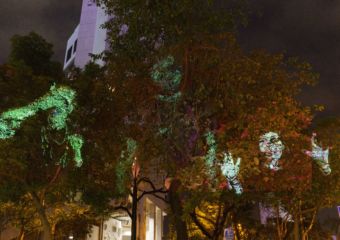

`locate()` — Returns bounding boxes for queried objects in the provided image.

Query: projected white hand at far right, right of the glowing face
[305,133,332,175]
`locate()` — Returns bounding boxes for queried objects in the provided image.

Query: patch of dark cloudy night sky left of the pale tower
[0,0,82,63]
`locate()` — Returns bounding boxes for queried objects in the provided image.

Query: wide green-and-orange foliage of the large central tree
[49,0,337,238]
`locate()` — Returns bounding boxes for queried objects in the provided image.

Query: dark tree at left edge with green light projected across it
[0,33,89,240]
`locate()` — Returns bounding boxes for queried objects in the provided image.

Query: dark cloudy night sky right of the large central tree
[239,0,340,114]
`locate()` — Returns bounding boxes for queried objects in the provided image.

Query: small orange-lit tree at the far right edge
[288,117,340,239]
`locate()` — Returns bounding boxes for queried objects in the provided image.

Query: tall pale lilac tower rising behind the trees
[64,0,109,71]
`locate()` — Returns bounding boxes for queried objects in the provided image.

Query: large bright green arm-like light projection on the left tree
[0,85,84,167]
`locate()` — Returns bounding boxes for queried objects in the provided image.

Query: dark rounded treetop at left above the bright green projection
[0,33,64,111]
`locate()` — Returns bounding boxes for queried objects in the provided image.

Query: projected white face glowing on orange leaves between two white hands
[259,132,285,171]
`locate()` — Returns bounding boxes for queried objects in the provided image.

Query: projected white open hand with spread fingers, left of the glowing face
[221,153,243,195]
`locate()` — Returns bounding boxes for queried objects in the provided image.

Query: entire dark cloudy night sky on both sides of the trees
[0,0,340,115]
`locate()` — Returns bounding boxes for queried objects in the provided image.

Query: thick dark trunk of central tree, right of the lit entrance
[169,179,188,240]
